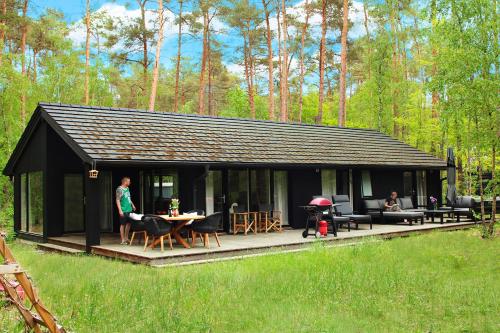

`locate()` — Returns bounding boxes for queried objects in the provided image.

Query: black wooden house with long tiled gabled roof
[3,103,446,246]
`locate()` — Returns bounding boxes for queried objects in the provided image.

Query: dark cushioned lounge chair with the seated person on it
[363,199,424,225]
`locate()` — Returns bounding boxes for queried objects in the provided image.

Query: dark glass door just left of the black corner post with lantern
[64,173,85,233]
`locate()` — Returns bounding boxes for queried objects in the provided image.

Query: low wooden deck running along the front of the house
[49,221,474,266]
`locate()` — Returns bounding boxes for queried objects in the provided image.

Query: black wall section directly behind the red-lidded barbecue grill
[288,170,321,228]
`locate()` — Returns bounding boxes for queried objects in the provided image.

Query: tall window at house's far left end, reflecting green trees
[20,171,43,234]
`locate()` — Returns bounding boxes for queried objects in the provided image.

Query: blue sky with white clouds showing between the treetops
[30,0,372,74]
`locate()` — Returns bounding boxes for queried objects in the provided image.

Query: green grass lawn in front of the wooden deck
[0,230,500,332]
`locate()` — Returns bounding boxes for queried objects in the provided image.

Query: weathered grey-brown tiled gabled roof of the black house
[2,103,446,174]
